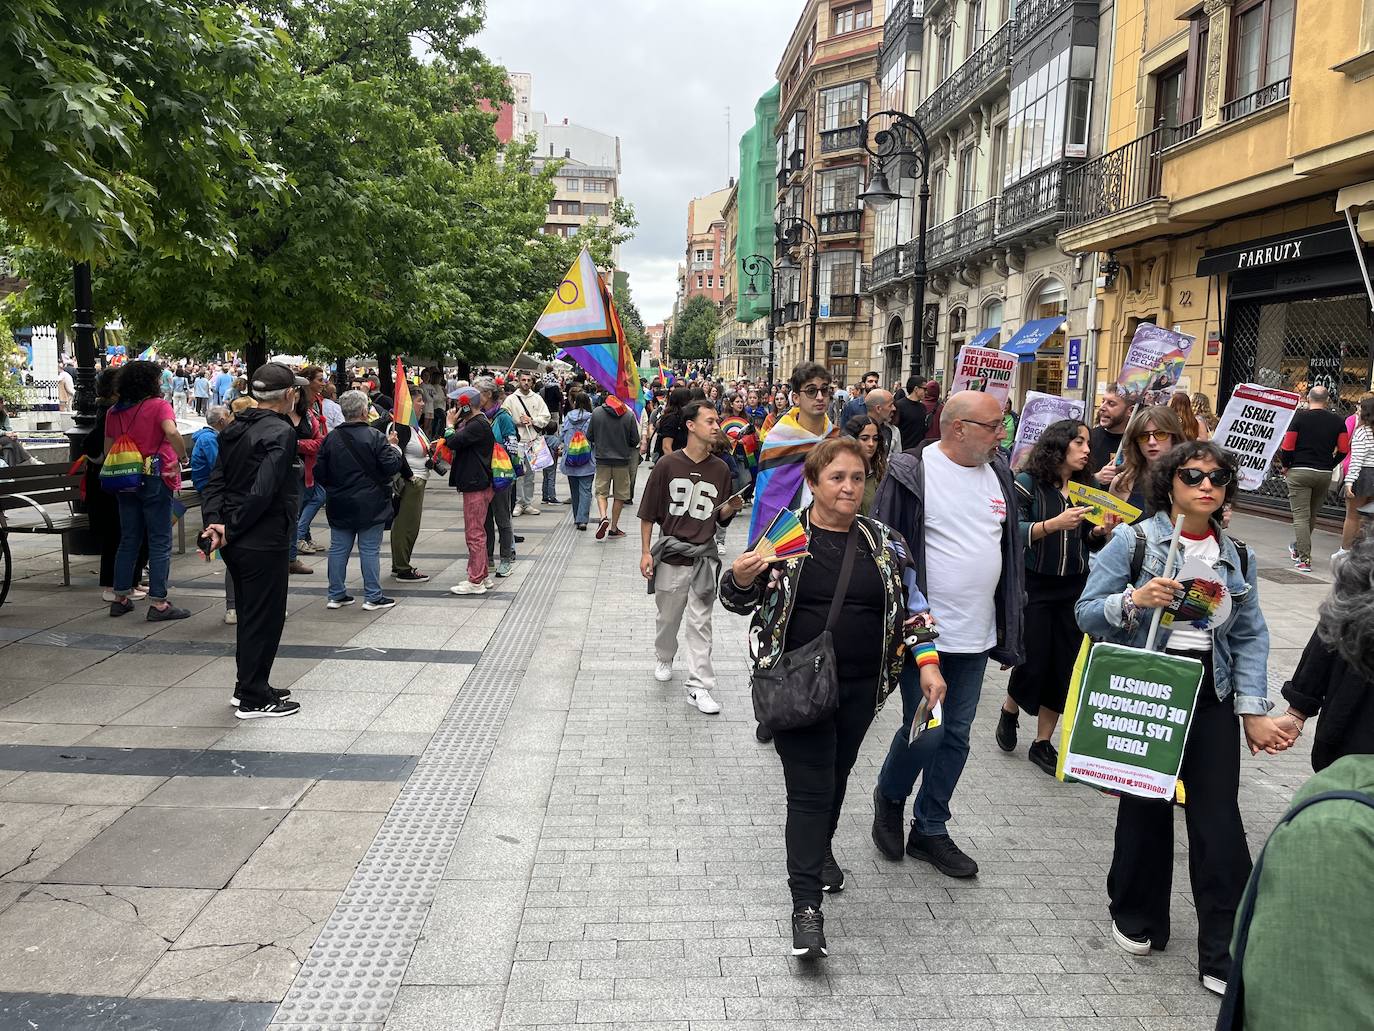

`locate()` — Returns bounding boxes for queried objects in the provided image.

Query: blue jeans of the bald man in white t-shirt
[878,652,988,834]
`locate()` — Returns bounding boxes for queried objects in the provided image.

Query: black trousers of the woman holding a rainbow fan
[774,678,878,910]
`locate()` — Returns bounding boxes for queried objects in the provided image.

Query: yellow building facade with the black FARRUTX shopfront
[1059,0,1374,514]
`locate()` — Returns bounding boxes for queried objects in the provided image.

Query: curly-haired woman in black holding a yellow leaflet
[996,419,1114,777]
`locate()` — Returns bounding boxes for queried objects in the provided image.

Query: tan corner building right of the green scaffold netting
[771,0,883,385]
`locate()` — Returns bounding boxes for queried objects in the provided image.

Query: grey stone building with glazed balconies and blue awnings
[866,0,1099,404]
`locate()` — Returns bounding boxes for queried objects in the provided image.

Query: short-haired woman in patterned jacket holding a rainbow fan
[720,437,944,960]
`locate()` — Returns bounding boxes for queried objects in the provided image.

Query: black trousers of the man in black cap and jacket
[220,547,290,707]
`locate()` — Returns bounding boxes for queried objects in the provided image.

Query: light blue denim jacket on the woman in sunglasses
[1074,513,1274,715]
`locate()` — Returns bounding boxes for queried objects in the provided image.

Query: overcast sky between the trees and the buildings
[477,0,802,323]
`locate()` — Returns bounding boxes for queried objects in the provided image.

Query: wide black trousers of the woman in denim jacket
[1107,656,1250,980]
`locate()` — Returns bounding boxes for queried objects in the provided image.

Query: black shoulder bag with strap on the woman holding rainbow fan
[750,526,859,730]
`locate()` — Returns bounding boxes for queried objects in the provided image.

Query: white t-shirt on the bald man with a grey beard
[922,444,1007,653]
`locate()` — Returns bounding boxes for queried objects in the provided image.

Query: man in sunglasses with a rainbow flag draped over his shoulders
[749,362,840,558]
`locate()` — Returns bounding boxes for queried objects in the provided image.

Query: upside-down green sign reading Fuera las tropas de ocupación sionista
[1061,643,1202,799]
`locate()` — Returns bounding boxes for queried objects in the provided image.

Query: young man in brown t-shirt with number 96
[639,401,745,713]
